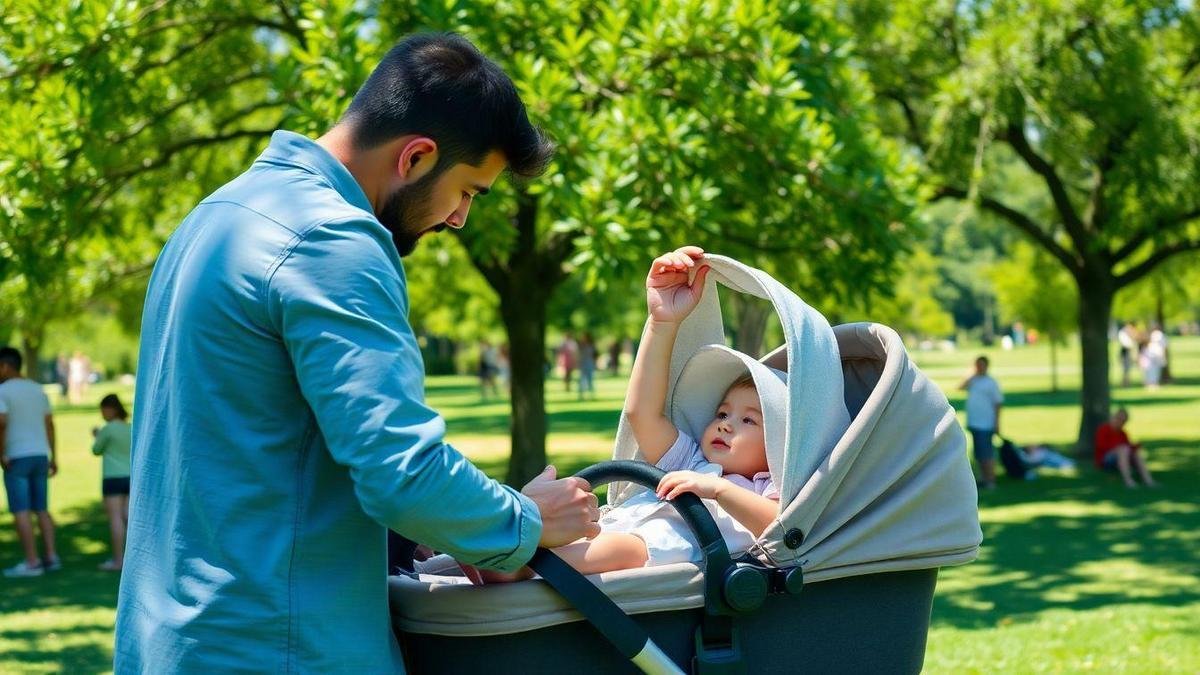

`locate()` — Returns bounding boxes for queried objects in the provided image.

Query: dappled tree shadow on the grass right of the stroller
[934,440,1200,628]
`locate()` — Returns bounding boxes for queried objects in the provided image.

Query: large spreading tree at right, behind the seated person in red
[838,0,1200,447]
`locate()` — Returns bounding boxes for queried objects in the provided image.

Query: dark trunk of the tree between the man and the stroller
[500,276,550,486]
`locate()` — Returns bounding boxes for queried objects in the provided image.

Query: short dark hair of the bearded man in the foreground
[342,32,554,177]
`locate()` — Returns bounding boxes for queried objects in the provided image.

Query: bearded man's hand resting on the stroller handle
[521,466,600,549]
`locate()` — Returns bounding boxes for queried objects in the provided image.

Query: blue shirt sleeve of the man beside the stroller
[264,222,541,571]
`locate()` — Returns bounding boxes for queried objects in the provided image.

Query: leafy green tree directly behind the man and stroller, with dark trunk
[421,1,906,483]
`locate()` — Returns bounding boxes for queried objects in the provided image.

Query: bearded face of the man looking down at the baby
[377,151,505,256]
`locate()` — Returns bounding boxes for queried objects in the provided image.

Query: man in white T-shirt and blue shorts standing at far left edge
[0,347,62,577]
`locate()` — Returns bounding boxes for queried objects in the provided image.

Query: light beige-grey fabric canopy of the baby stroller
[610,255,982,581]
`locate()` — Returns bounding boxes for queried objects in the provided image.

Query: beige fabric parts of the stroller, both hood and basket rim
[390,256,982,635]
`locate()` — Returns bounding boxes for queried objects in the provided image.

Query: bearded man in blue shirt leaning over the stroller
[115,35,599,674]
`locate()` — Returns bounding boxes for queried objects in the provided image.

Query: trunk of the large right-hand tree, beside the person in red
[1076,275,1114,454]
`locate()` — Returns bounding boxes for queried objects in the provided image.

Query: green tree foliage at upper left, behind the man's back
[0,0,287,362]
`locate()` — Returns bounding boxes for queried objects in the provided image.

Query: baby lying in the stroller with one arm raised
[477,246,782,583]
